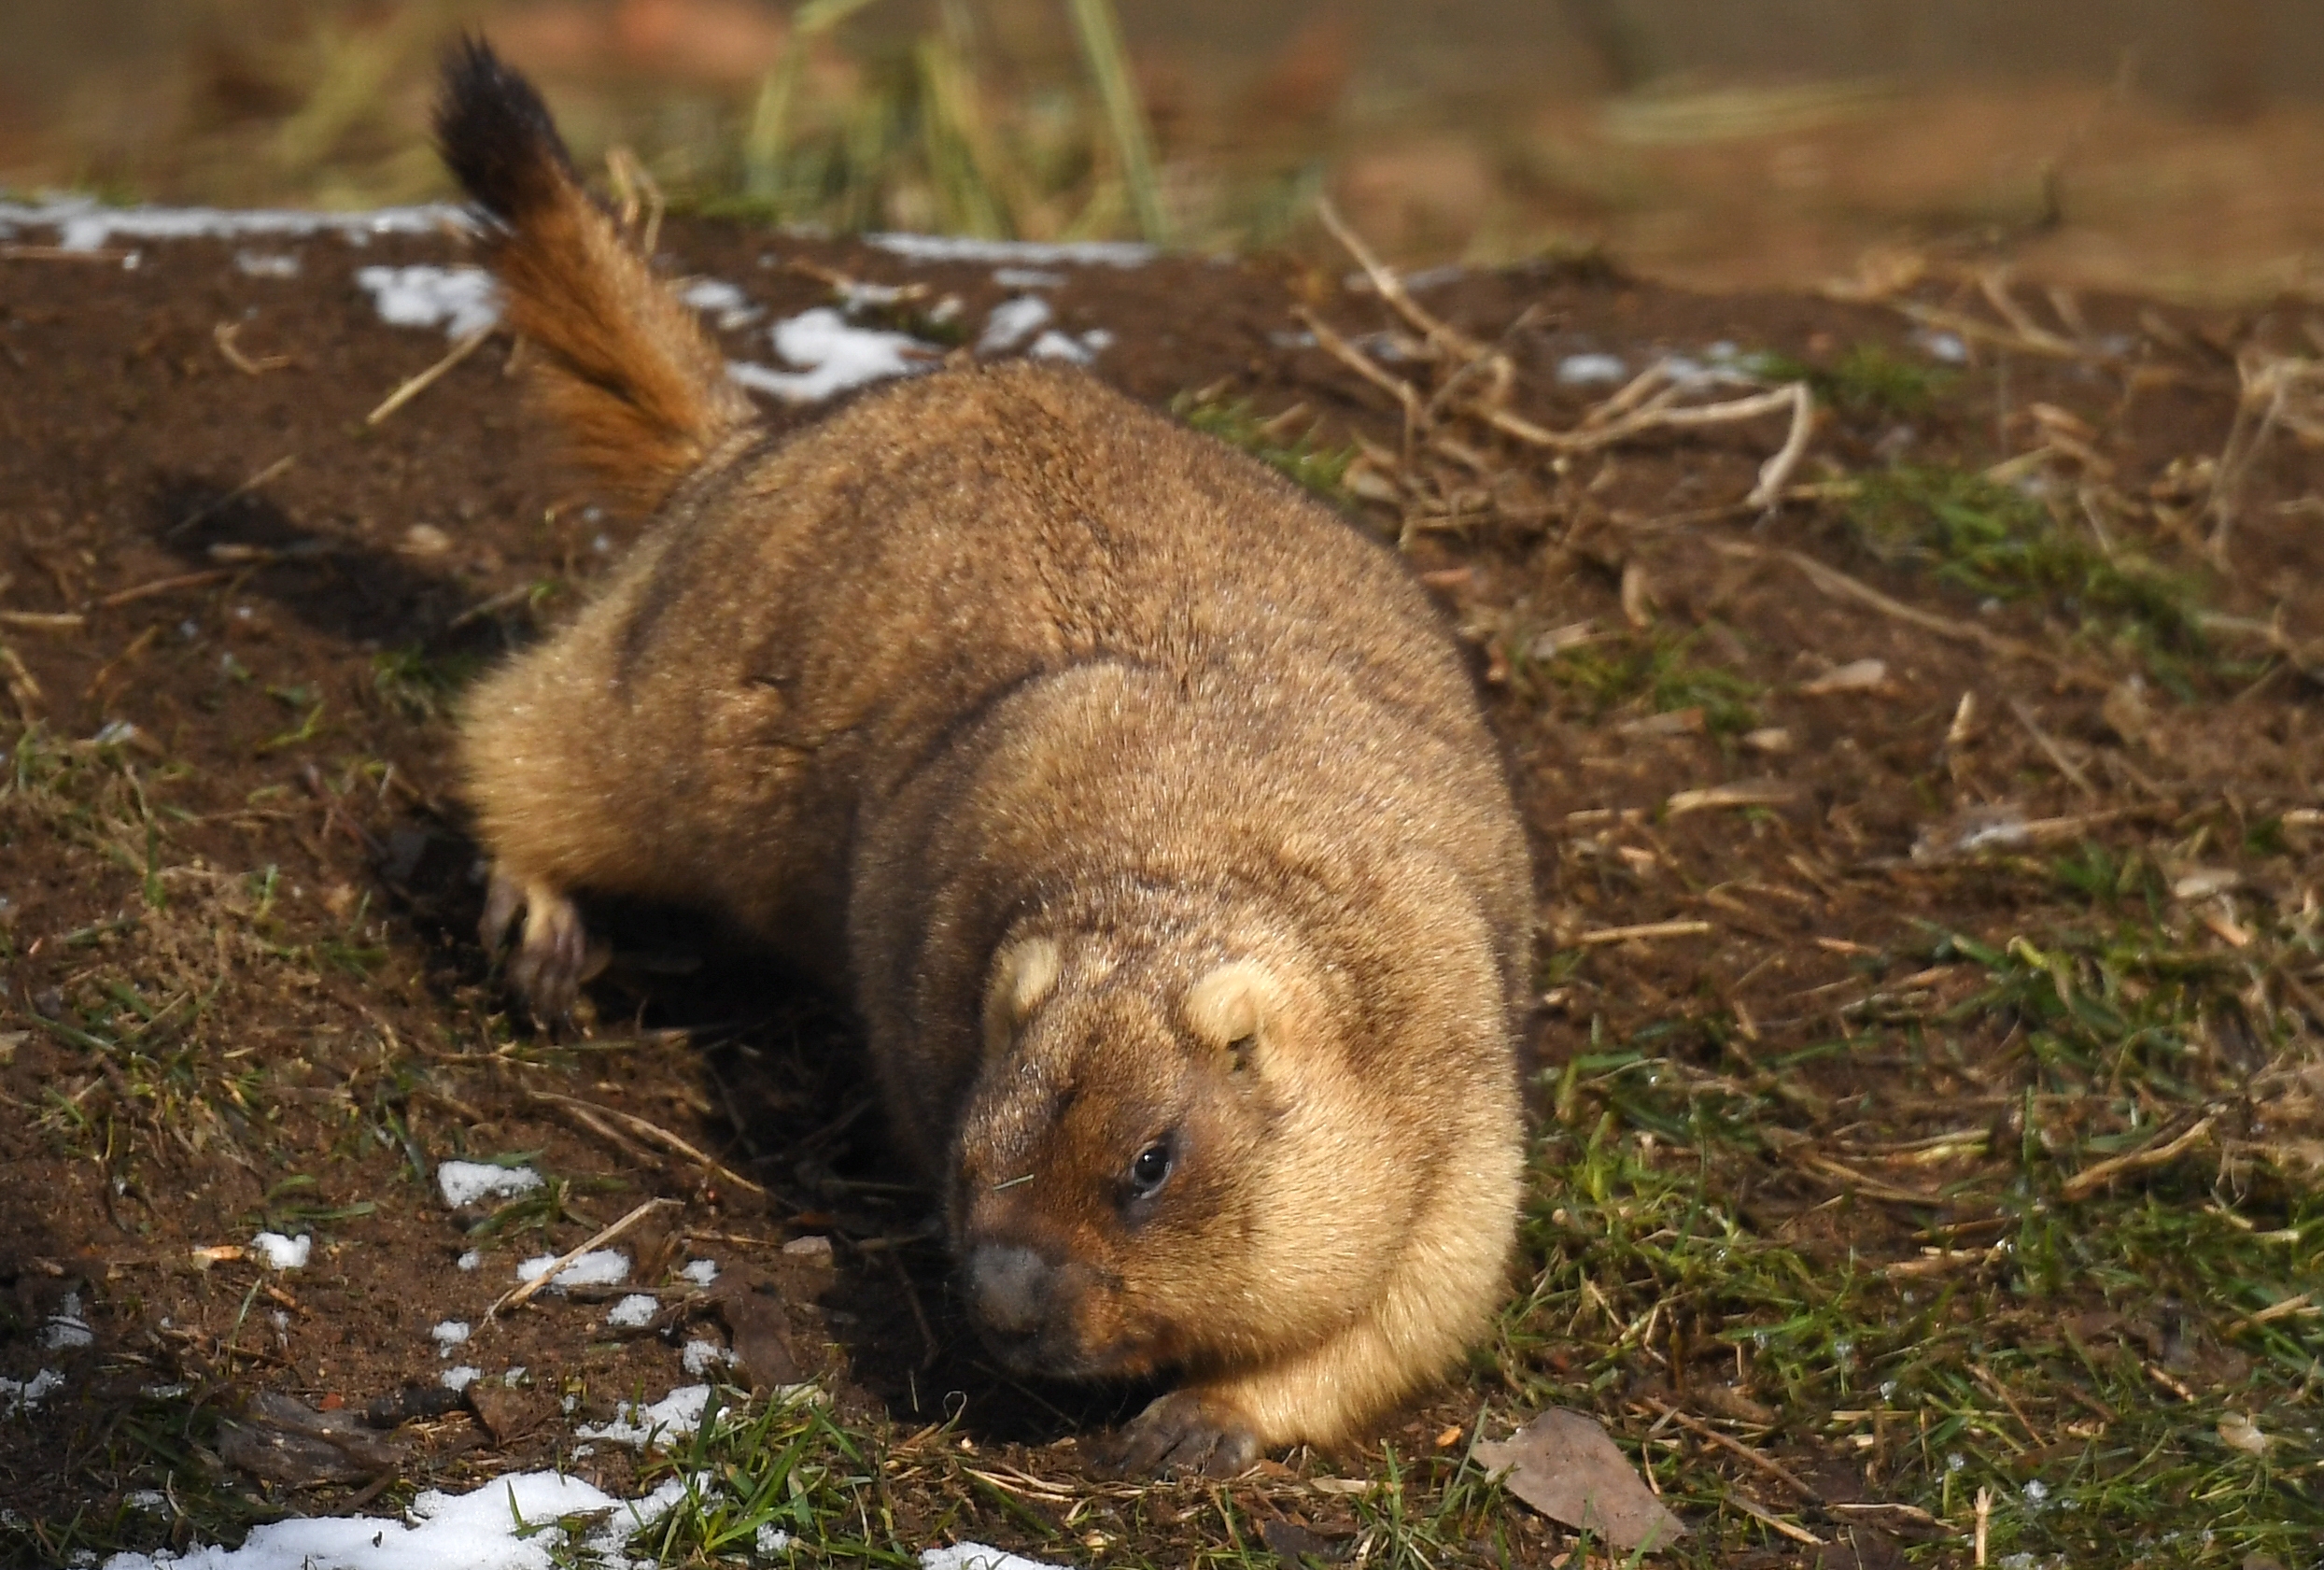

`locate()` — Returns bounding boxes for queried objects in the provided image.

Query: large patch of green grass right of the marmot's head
[1524,865,2324,1568]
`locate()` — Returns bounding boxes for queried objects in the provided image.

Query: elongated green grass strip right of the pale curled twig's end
[1845,468,2208,677]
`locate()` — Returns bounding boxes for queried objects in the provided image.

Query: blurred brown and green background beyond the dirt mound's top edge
[0,0,2324,300]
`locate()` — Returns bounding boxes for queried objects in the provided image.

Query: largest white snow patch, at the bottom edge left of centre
[105,1472,678,1570]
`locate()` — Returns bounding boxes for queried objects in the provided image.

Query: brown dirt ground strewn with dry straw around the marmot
[0,221,2324,1565]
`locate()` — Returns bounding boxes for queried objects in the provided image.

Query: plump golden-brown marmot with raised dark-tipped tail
[437,42,1531,1472]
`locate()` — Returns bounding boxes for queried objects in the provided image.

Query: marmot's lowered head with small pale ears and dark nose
[949,933,1413,1379]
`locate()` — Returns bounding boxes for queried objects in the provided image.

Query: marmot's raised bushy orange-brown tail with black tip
[434,39,755,512]
